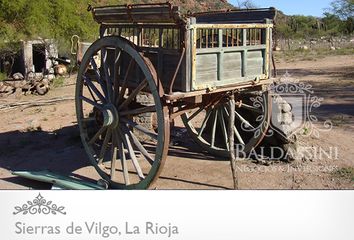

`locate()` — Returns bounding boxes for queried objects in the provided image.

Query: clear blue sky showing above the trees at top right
[229,0,333,17]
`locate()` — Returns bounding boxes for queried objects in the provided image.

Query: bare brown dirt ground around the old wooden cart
[0,56,354,189]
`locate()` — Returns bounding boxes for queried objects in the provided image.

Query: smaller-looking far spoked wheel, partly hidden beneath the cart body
[182,92,271,157]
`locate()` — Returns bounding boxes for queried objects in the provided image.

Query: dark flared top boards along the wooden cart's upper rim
[92,3,276,25]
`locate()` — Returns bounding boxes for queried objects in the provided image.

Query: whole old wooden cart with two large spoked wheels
[76,3,275,189]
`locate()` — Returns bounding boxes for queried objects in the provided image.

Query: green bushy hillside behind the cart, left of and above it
[0,0,232,51]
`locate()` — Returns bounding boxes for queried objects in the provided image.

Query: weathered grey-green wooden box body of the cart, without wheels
[92,3,275,94]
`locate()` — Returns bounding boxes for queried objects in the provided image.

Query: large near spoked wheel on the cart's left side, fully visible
[76,36,169,189]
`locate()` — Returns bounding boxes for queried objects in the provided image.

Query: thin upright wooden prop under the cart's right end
[228,94,238,189]
